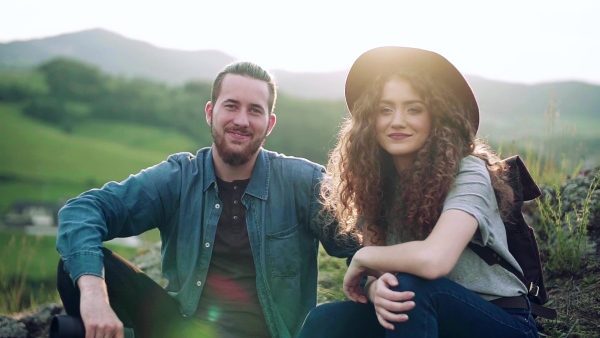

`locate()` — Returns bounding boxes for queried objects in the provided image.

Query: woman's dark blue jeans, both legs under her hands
[299,273,538,338]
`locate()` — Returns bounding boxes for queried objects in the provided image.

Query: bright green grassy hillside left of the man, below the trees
[0,104,206,210]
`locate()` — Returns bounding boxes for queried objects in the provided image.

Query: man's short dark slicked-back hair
[210,61,277,114]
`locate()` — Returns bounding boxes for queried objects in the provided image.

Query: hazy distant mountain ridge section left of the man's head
[0,29,234,83]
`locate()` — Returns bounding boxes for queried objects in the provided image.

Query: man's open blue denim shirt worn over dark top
[57,148,356,337]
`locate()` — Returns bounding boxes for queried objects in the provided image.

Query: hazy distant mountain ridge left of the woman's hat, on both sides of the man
[0,28,346,99]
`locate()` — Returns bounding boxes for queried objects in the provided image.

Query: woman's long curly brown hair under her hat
[321,71,513,243]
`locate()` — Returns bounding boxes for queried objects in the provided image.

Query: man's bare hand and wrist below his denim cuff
[77,275,124,338]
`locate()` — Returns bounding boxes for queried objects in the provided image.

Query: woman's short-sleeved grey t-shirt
[386,156,527,300]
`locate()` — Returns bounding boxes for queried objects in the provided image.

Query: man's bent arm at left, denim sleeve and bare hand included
[56,157,188,337]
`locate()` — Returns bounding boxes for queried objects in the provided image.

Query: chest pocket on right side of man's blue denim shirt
[267,224,301,278]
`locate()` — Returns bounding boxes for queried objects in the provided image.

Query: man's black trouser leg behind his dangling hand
[57,248,201,338]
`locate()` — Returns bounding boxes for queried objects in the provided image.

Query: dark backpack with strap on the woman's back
[469,155,556,319]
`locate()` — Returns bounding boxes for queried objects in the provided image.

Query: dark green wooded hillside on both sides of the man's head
[0,57,346,163]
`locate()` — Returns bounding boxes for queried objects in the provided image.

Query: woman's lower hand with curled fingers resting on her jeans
[365,273,415,330]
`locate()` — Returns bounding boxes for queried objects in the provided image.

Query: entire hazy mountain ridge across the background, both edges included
[0,29,600,133]
